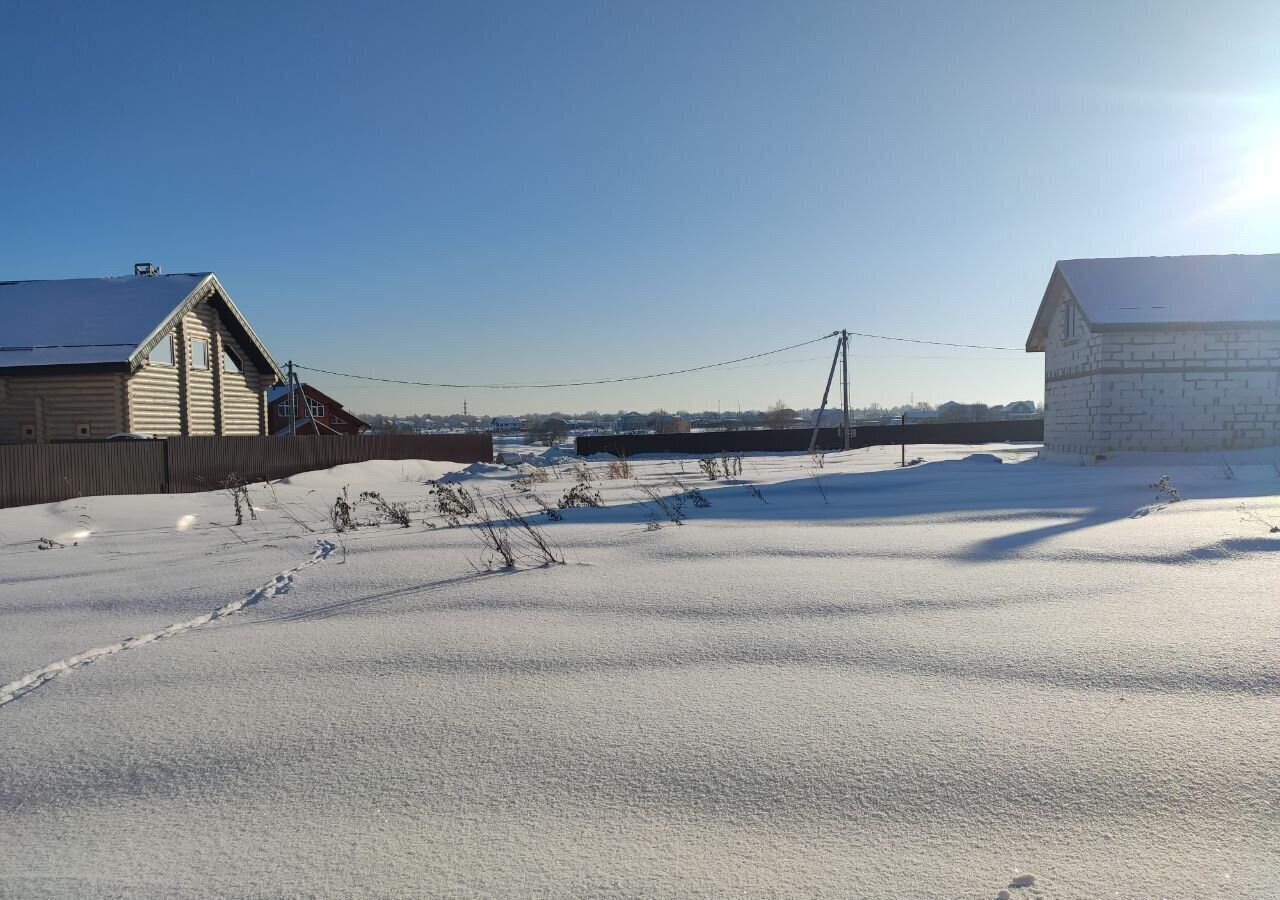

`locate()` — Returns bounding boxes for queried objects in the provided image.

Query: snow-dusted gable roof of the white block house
[1027,253,1280,352]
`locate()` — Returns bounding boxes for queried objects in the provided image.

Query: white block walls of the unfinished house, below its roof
[1044,291,1280,454]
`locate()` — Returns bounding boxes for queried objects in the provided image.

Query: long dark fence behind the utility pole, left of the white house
[575,419,1044,456]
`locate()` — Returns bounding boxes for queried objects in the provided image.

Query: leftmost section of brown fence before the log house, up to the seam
[0,440,165,507]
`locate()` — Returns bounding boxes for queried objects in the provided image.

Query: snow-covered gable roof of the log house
[0,271,280,378]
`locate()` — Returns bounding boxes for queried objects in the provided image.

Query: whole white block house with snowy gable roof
[1027,253,1280,458]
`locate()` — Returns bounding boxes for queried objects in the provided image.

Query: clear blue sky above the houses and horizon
[0,0,1280,414]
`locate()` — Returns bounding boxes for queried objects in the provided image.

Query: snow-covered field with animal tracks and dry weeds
[0,446,1280,899]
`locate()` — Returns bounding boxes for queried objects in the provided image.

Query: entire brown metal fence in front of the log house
[0,434,493,508]
